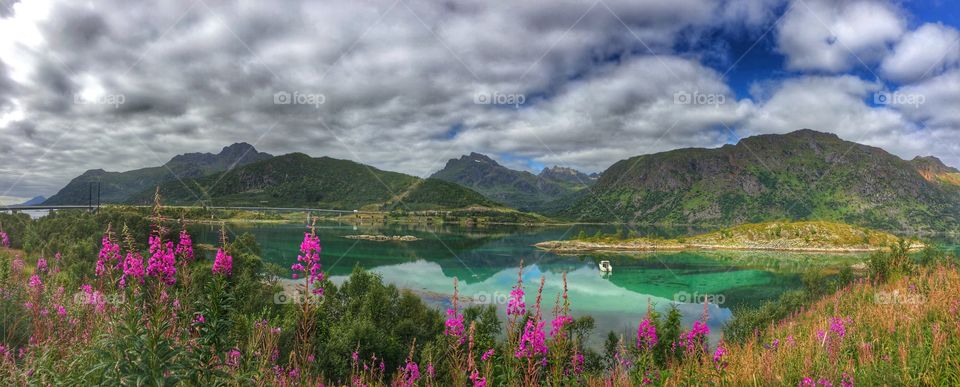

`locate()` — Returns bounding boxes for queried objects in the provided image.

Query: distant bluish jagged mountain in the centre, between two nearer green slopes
[431,153,595,211]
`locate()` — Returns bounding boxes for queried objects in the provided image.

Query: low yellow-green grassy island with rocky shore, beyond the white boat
[534,221,924,254]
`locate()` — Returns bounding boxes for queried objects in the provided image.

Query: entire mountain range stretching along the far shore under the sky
[46,129,960,230]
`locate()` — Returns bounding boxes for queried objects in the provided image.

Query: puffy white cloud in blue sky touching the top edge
[777,0,905,72]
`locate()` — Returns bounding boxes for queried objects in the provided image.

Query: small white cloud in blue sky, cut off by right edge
[880,23,960,83]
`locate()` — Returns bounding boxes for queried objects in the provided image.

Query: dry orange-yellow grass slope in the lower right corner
[665,265,960,386]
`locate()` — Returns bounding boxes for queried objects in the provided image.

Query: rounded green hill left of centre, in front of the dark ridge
[129,153,506,210]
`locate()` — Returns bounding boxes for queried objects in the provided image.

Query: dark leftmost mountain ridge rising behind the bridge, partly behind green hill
[44,143,273,205]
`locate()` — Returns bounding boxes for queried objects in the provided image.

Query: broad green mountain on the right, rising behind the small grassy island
[552,129,960,230]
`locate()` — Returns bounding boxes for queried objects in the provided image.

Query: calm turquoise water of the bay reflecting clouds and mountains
[195,223,865,348]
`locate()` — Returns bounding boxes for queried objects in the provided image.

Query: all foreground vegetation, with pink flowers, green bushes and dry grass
[0,207,960,386]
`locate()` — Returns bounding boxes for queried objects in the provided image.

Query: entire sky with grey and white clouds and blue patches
[0,0,960,200]
